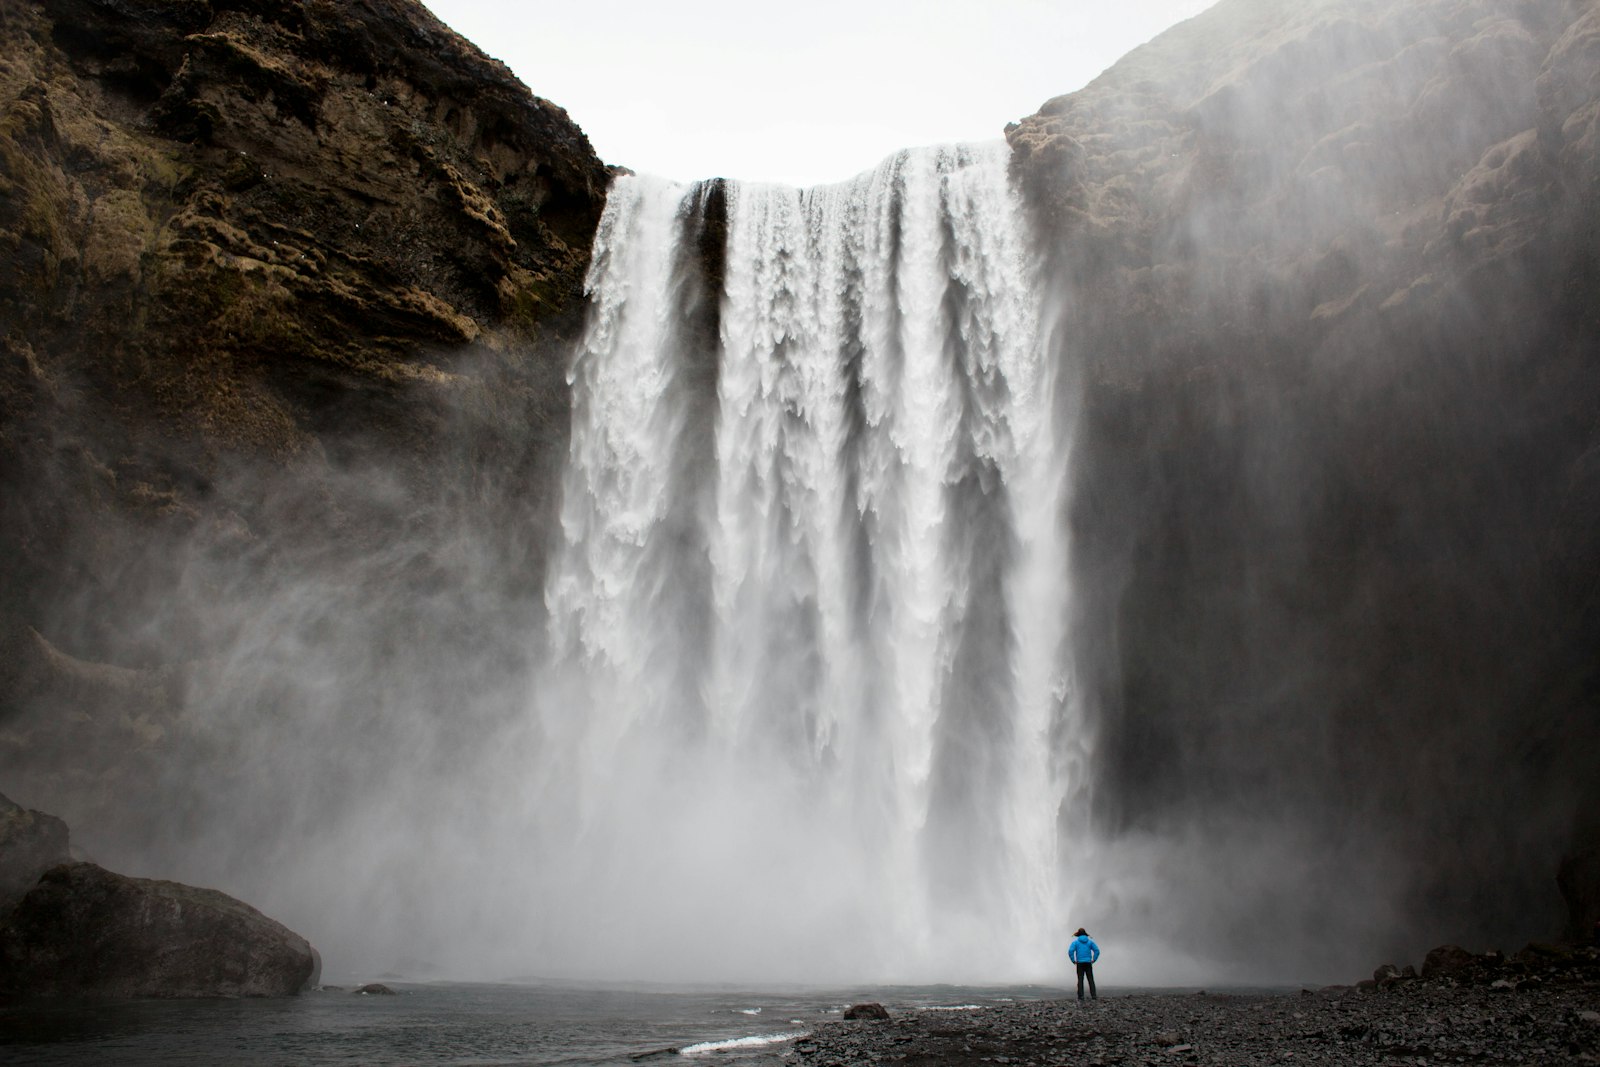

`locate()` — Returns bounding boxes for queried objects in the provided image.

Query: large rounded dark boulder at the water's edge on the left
[0,864,322,997]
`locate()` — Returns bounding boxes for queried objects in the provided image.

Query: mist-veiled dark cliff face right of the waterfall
[1008,0,1600,960]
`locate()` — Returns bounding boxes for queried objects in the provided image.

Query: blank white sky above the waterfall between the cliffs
[424,0,1214,186]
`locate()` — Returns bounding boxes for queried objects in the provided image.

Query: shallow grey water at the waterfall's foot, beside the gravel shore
[0,982,1066,1067]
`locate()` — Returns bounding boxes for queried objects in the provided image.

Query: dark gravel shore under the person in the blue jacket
[784,947,1600,1067]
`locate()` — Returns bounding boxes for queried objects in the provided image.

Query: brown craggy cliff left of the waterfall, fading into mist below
[0,0,608,835]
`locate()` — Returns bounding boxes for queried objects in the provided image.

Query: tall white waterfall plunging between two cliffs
[530,144,1075,981]
